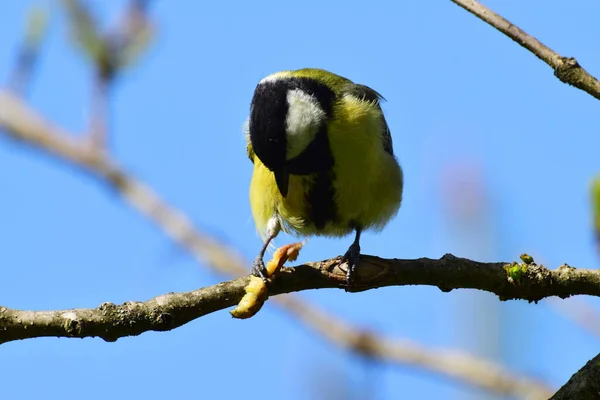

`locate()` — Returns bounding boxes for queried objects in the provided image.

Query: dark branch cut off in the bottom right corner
[551,354,600,400]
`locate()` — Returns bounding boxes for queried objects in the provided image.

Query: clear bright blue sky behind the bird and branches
[0,0,600,399]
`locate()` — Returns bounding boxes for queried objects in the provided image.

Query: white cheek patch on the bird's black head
[285,89,325,160]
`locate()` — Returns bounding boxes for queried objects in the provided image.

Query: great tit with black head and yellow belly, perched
[247,68,403,289]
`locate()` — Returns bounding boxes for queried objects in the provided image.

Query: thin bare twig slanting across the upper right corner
[451,0,600,100]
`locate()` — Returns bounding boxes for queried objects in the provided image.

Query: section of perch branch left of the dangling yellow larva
[0,278,248,344]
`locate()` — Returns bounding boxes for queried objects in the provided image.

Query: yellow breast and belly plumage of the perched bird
[250,96,402,236]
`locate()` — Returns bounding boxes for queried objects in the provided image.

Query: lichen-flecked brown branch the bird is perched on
[0,254,600,342]
